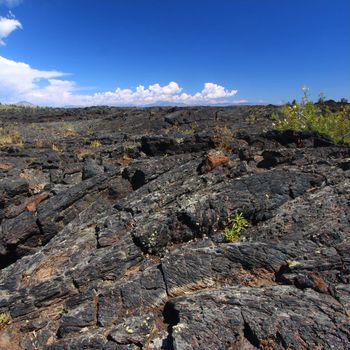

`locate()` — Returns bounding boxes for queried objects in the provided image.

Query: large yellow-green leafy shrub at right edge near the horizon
[273,87,350,143]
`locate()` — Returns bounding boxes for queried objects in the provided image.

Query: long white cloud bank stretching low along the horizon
[0,56,242,106]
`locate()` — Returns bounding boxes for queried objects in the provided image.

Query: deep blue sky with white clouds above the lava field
[0,0,350,105]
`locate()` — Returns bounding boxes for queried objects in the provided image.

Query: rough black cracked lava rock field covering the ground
[0,106,350,350]
